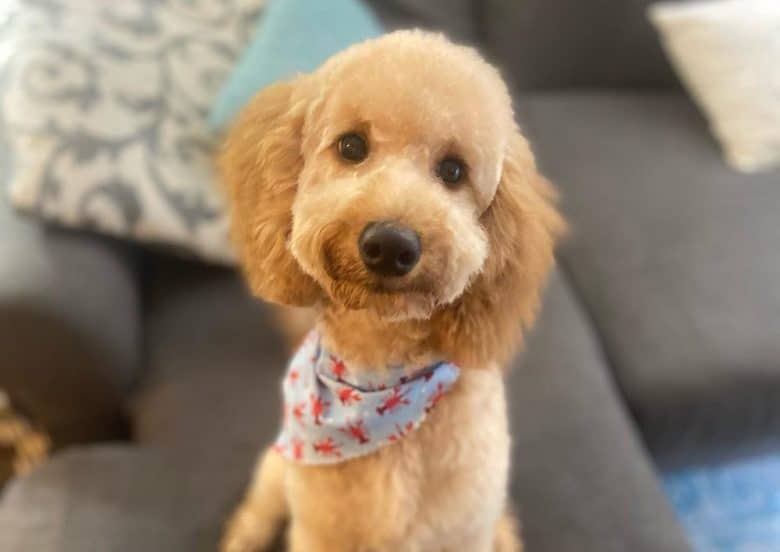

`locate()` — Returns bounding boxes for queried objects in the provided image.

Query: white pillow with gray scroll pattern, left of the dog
[0,0,261,262]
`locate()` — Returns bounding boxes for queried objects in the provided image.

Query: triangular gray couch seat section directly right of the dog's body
[508,274,689,552]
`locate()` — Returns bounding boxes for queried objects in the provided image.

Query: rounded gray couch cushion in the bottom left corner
[0,445,232,552]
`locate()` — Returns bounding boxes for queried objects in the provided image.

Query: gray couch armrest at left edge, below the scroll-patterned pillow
[0,194,140,444]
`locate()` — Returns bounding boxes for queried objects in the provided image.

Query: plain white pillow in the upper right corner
[649,0,780,172]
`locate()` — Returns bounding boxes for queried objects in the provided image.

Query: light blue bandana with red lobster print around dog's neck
[274,332,459,464]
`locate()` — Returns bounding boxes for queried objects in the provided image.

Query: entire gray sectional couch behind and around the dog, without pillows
[0,0,780,552]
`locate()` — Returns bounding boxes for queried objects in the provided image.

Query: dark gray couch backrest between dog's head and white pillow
[474,0,679,90]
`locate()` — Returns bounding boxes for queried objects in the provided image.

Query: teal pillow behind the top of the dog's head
[209,0,383,131]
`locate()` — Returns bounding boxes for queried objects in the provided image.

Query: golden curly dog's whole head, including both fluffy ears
[220,31,561,344]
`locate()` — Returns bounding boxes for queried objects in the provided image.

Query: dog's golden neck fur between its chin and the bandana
[317,305,438,367]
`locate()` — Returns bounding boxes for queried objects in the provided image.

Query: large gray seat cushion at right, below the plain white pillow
[518,93,780,462]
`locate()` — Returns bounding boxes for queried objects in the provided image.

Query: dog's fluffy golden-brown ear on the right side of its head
[438,133,566,367]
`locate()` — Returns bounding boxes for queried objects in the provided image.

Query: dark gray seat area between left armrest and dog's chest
[130,259,287,508]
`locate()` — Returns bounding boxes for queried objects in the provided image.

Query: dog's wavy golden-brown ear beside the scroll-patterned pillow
[218,76,321,306]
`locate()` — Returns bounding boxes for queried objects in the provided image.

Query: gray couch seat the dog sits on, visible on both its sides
[133,263,686,552]
